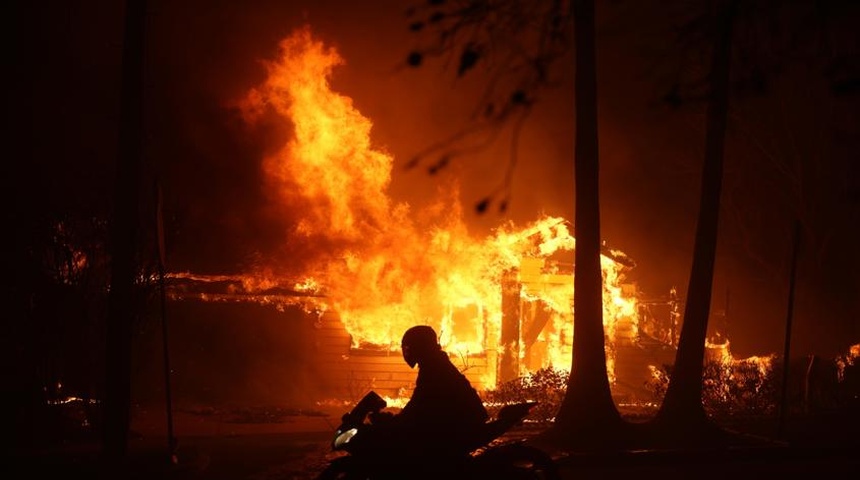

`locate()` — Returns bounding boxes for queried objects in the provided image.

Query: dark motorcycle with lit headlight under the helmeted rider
[317,391,561,480]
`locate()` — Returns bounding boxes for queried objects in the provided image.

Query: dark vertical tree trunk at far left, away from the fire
[102,0,146,461]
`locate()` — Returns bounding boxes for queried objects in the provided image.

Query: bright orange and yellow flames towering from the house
[235,24,637,384]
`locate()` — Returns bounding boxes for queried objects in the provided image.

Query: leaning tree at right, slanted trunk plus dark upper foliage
[652,0,856,445]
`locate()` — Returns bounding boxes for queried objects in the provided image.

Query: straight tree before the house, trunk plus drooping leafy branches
[400,0,626,448]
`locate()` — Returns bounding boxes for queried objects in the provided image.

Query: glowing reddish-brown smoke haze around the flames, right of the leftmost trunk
[150,1,857,360]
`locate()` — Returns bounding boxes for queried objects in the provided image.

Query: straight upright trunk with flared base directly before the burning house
[546,0,623,448]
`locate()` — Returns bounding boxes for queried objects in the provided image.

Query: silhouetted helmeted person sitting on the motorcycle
[358,325,489,462]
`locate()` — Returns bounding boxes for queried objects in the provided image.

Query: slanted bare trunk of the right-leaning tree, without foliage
[655,0,737,442]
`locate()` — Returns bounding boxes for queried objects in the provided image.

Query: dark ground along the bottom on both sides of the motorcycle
[6,406,860,480]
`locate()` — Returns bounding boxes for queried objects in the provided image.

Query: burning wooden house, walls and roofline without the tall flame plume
[165,240,647,403]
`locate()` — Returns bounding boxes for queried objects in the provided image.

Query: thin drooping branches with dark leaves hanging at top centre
[405,0,571,213]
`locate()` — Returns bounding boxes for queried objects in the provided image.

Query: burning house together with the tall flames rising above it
[160,29,672,406]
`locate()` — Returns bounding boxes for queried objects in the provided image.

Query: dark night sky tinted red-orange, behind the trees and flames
[4,0,860,355]
